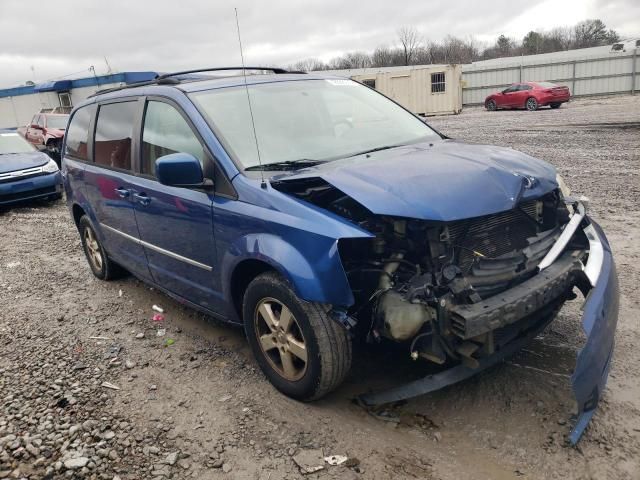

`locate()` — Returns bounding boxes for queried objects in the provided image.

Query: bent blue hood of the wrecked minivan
[271,140,558,221]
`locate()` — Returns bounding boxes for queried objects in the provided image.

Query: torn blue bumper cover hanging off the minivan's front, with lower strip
[360,203,619,445]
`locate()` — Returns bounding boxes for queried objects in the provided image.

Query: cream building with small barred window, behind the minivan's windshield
[321,65,462,115]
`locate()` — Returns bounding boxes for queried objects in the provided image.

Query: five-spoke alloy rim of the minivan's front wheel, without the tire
[254,298,308,381]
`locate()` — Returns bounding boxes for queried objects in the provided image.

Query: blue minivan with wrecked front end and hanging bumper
[62,68,618,442]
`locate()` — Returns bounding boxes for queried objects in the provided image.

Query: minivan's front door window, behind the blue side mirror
[142,101,205,175]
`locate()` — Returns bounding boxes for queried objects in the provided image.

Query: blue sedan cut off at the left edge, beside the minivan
[0,130,62,206]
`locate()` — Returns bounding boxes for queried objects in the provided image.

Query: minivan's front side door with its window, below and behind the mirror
[131,99,220,310]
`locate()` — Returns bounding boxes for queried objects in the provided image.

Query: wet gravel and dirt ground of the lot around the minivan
[0,96,640,480]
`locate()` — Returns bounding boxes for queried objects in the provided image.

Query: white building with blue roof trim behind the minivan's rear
[0,72,157,128]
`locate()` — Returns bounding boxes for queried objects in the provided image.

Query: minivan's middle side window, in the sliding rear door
[93,102,138,170]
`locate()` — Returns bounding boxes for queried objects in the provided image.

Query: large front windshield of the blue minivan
[190,79,440,168]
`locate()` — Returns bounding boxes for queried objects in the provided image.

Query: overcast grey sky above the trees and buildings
[0,0,640,87]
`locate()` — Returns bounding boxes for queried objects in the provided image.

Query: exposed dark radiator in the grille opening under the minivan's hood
[448,200,542,272]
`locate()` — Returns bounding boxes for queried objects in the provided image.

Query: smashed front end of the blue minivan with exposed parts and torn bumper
[274,178,618,444]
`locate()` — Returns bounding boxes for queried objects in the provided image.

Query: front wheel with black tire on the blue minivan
[242,272,352,401]
